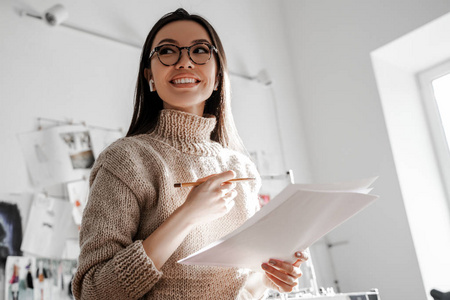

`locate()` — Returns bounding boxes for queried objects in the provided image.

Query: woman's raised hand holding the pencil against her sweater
[180,171,241,225]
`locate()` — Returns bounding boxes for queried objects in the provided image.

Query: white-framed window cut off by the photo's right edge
[418,61,450,206]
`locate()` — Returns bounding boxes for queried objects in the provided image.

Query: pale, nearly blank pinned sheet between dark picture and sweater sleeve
[21,194,78,259]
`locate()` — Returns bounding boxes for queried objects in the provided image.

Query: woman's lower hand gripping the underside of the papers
[261,251,308,293]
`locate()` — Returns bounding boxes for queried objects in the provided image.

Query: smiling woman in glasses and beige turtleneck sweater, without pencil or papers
[73,9,306,299]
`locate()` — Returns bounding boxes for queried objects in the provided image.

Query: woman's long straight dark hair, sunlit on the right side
[127,8,247,153]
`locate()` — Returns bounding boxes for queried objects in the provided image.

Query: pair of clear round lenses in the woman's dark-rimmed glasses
[158,44,211,66]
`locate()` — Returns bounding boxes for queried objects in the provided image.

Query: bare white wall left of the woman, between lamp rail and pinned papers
[0,1,139,193]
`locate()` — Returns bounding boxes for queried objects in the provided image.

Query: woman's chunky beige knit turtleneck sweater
[73,109,260,300]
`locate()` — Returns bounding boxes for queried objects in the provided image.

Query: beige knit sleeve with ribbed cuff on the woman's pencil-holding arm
[73,166,162,300]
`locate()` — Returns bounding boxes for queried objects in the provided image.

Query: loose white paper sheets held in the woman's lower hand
[179,178,378,270]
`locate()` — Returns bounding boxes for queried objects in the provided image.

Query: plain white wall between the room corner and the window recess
[283,0,450,299]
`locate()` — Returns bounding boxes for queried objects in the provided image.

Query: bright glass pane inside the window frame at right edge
[432,73,450,151]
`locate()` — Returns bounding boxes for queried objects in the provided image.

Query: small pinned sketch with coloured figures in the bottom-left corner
[4,256,35,300]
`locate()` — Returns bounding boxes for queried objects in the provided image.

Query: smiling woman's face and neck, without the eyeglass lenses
[145,21,217,116]
